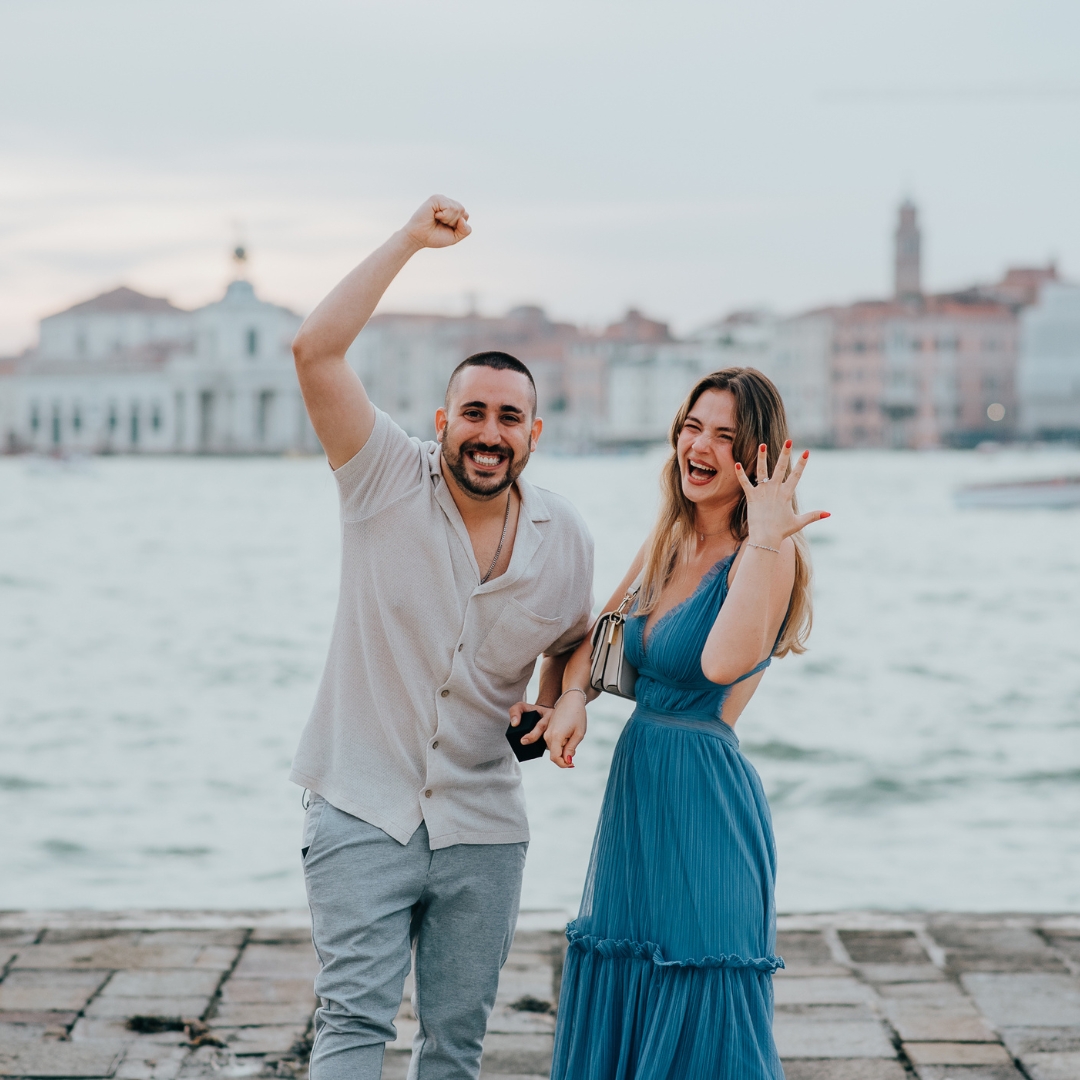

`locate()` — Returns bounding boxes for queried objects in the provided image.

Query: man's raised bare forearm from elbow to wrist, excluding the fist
[293,229,422,364]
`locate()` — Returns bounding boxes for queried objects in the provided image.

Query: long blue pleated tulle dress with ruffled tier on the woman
[551,555,784,1080]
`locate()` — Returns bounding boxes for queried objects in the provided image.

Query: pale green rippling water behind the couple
[0,450,1080,910]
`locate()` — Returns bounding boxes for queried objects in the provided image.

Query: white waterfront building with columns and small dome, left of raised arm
[0,280,319,455]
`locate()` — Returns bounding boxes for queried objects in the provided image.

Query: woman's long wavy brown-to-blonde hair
[637,367,813,657]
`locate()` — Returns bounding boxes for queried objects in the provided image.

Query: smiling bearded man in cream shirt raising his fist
[292,195,593,1080]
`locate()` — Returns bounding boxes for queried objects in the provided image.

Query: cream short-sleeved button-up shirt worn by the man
[289,409,593,849]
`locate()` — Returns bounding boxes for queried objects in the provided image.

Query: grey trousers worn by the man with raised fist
[303,795,528,1080]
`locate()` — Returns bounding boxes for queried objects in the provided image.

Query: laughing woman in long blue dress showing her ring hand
[535,367,828,1080]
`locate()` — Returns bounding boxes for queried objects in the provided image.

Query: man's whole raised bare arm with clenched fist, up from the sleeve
[293,195,472,469]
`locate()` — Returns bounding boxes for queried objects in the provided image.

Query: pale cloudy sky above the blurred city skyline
[0,0,1080,347]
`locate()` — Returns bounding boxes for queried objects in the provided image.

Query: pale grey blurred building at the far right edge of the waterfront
[1017,281,1080,438]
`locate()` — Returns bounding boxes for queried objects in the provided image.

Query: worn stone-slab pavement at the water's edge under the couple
[0,912,1080,1080]
